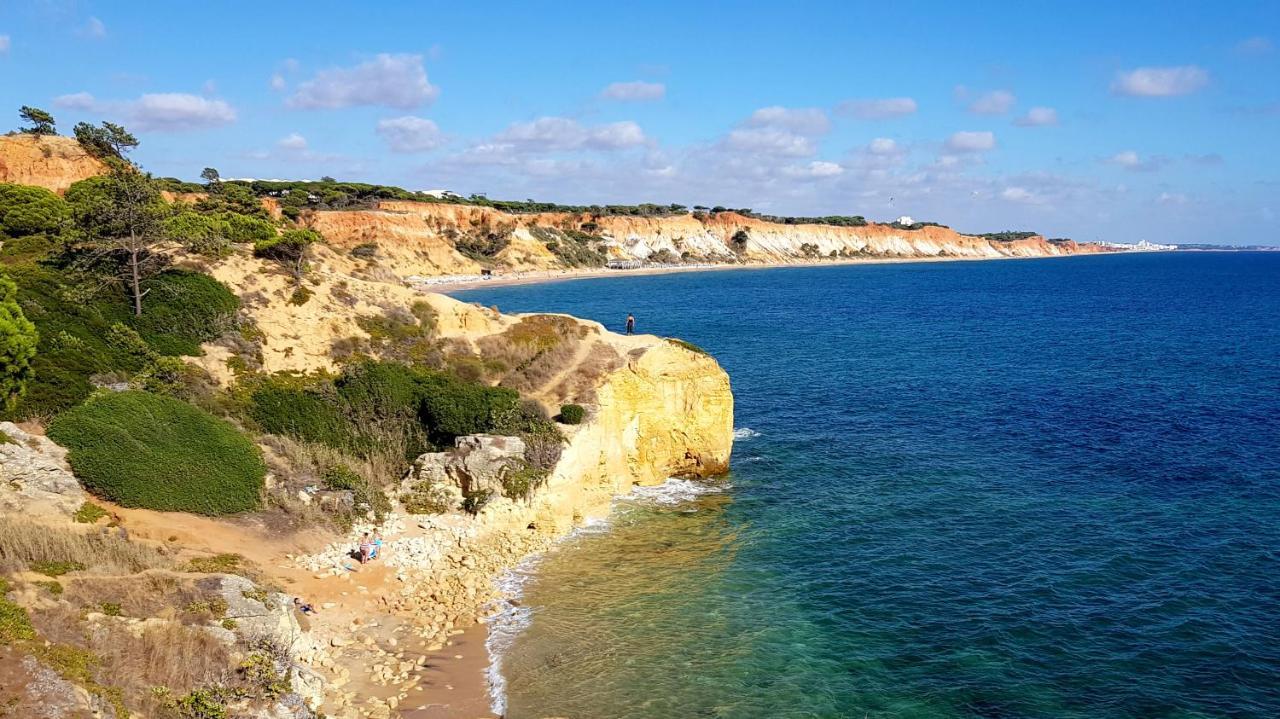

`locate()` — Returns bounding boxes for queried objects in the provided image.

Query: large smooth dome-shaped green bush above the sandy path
[49,391,266,514]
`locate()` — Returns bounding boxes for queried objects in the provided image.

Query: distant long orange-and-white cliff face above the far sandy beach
[310,201,1105,276]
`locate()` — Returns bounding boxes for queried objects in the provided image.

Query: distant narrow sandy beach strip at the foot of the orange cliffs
[422,249,1152,294]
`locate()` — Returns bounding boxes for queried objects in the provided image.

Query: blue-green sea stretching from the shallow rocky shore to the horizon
[454,253,1280,719]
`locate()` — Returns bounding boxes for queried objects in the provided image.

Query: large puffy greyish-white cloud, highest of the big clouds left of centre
[287,52,440,110]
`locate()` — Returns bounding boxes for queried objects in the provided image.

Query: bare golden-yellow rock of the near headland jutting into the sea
[193,244,733,498]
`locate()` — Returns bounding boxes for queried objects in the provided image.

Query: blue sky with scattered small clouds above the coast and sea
[0,0,1280,243]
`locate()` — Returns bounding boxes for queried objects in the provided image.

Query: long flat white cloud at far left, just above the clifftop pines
[54,92,236,132]
